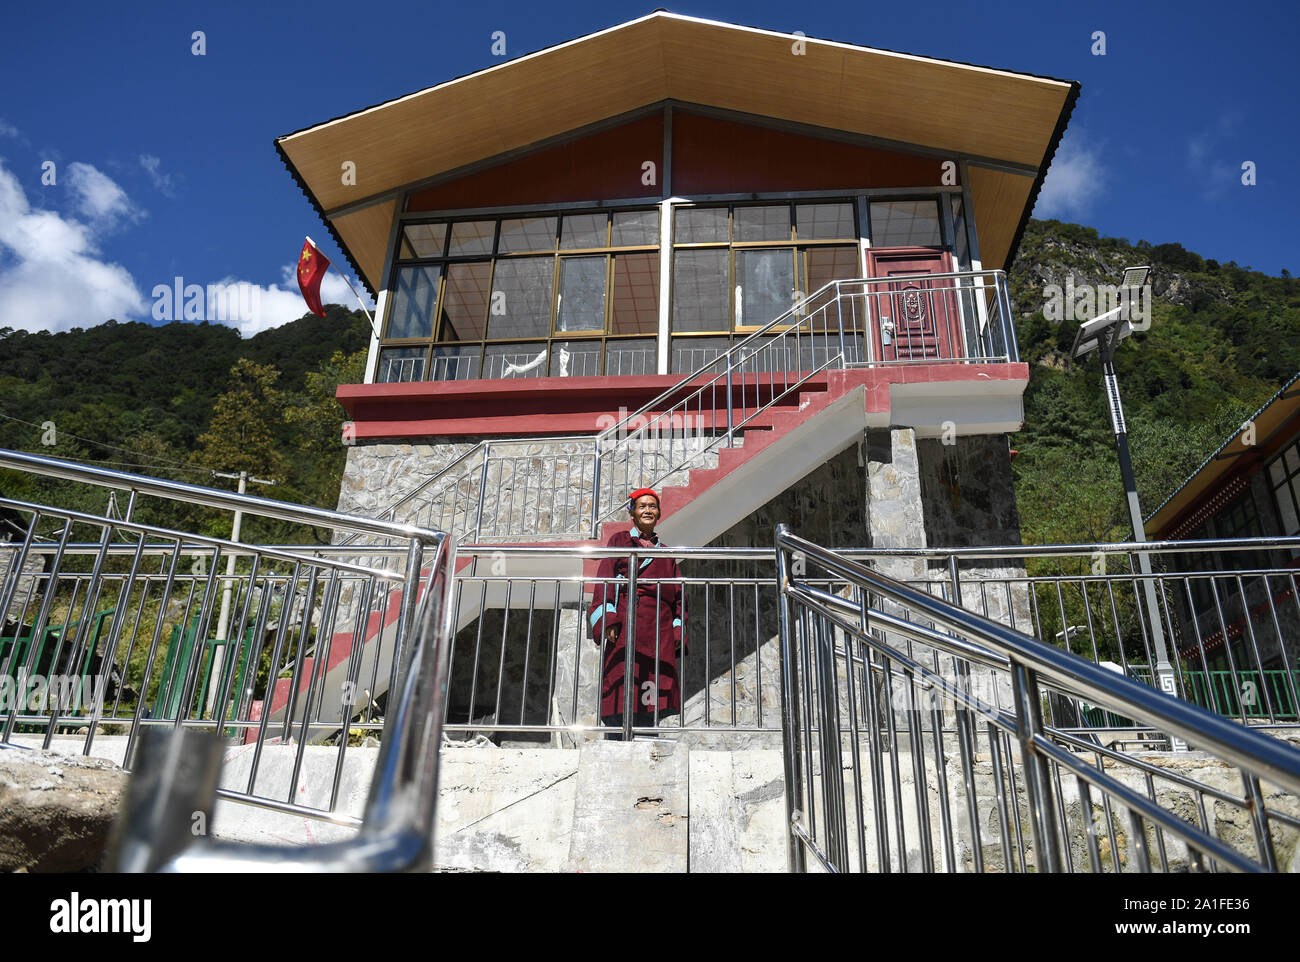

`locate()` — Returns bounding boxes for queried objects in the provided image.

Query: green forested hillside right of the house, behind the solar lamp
[1010,221,1300,543]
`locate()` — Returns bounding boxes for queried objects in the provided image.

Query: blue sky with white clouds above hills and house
[0,0,1300,334]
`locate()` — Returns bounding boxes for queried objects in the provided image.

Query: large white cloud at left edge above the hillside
[0,164,146,332]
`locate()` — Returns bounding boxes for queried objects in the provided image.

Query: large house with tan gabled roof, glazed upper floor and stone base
[276,12,1079,738]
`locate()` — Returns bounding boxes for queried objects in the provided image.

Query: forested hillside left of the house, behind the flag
[0,304,369,540]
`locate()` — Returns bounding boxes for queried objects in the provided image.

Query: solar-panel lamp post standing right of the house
[1070,267,1187,750]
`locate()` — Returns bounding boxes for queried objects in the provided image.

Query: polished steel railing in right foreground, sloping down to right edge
[776,525,1300,872]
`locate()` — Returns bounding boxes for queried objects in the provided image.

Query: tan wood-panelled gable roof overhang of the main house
[276,12,1079,291]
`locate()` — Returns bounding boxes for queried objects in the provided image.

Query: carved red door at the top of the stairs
[867,248,963,361]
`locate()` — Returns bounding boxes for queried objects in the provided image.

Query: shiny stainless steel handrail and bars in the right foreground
[775,525,1300,871]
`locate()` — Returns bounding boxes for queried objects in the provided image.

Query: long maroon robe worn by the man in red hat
[588,532,686,718]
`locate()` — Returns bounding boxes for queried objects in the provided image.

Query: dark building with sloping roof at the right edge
[1145,374,1300,719]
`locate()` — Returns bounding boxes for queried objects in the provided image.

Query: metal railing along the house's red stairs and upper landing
[353,270,1017,542]
